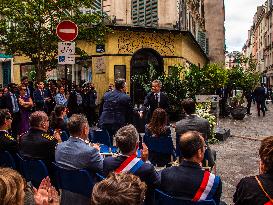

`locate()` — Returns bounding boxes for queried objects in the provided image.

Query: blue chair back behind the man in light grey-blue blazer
[53,163,95,197]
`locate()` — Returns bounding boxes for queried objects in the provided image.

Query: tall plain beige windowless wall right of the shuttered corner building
[204,0,226,63]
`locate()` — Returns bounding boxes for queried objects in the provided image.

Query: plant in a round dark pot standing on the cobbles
[230,94,247,120]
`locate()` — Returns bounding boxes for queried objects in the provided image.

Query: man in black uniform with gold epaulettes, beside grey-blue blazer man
[19,111,61,162]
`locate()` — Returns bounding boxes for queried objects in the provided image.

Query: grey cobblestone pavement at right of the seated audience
[211,103,273,205]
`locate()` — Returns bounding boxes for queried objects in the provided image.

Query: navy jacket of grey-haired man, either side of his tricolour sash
[103,156,160,187]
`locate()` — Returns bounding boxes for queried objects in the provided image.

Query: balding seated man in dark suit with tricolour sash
[160,131,222,205]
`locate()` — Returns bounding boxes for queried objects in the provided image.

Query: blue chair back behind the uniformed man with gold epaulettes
[23,159,49,188]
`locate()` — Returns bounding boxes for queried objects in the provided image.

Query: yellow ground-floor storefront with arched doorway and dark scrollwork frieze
[78,27,208,100]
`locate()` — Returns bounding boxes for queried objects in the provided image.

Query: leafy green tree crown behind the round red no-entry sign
[0,0,108,81]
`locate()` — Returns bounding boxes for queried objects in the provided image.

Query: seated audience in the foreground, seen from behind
[0,97,273,205]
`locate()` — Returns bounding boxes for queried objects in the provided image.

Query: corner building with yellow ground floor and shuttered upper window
[11,0,209,100]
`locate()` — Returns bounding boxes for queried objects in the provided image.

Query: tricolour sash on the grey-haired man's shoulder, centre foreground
[115,154,144,174]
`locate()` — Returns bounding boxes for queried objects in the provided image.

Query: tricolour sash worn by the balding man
[192,171,220,201]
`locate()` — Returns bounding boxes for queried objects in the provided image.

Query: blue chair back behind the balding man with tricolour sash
[154,189,216,205]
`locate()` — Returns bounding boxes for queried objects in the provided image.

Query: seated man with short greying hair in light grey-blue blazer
[55,114,103,205]
